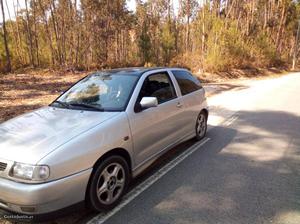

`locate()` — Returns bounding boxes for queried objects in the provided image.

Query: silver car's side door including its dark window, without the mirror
[128,71,183,164]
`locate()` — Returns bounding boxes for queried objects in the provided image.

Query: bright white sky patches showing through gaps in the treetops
[0,0,179,23]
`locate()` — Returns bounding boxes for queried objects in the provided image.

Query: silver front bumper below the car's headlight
[0,169,92,215]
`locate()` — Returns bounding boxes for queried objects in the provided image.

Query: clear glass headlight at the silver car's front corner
[11,163,50,181]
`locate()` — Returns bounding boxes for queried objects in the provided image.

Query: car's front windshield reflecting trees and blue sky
[51,72,138,111]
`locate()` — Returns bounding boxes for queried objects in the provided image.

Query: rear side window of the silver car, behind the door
[172,70,202,96]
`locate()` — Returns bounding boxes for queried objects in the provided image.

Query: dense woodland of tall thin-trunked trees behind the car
[0,0,300,73]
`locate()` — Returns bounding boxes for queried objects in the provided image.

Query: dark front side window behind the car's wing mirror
[138,72,177,104]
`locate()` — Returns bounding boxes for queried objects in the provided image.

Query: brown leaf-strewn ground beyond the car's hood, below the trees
[0,69,86,122]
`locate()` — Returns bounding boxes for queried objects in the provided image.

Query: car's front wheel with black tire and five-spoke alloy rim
[87,155,130,212]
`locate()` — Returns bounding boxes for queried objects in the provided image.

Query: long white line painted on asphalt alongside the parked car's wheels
[87,138,210,224]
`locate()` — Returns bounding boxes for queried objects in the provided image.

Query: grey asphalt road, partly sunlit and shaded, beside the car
[2,73,300,224]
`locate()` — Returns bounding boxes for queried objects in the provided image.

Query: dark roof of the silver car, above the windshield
[91,67,186,76]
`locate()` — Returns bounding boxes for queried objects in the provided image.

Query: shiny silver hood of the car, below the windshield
[0,107,120,164]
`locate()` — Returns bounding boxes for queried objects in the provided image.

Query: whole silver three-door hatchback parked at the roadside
[0,68,208,214]
